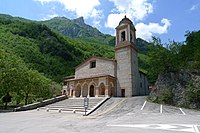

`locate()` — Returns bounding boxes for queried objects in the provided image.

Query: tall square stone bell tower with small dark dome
[115,16,139,97]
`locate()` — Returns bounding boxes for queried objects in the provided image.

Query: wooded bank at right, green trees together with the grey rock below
[148,30,200,109]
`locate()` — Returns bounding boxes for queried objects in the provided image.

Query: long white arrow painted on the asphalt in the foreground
[107,124,199,133]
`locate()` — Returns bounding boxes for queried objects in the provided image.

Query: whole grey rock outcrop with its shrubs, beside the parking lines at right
[150,71,200,108]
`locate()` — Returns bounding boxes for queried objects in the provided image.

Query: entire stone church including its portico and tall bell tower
[63,16,148,97]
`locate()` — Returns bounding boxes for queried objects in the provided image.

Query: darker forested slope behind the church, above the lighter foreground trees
[0,16,114,82]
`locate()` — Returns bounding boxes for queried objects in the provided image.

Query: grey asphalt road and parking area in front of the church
[0,97,200,133]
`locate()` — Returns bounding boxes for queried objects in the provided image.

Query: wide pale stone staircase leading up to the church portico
[39,97,109,115]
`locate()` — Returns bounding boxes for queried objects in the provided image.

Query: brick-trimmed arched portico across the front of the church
[65,75,115,97]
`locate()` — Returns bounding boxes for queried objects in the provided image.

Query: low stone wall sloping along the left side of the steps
[14,95,68,111]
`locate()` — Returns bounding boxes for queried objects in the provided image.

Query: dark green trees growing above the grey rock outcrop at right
[148,31,200,80]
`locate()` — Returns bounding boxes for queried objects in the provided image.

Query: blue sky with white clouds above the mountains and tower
[0,0,200,43]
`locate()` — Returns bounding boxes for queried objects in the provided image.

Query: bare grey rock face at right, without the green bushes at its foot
[151,71,200,108]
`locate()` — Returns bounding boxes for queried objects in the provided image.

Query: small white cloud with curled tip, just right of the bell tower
[135,18,171,40]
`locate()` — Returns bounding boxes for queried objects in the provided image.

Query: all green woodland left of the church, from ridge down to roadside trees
[0,15,114,104]
